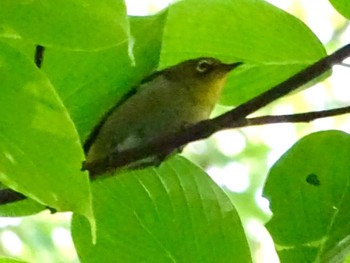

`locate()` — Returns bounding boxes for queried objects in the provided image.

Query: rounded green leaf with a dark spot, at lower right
[264,131,350,262]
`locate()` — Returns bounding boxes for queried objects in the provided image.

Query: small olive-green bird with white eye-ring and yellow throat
[84,57,242,173]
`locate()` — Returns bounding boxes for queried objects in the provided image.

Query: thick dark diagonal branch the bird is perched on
[83,44,350,178]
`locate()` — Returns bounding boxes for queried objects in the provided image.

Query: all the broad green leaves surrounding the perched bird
[0,0,350,262]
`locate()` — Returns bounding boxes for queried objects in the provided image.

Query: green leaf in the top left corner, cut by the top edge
[0,0,129,51]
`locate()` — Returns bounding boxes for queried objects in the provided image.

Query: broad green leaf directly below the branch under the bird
[72,157,251,263]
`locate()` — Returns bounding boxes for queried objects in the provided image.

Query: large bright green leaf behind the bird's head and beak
[161,0,325,105]
